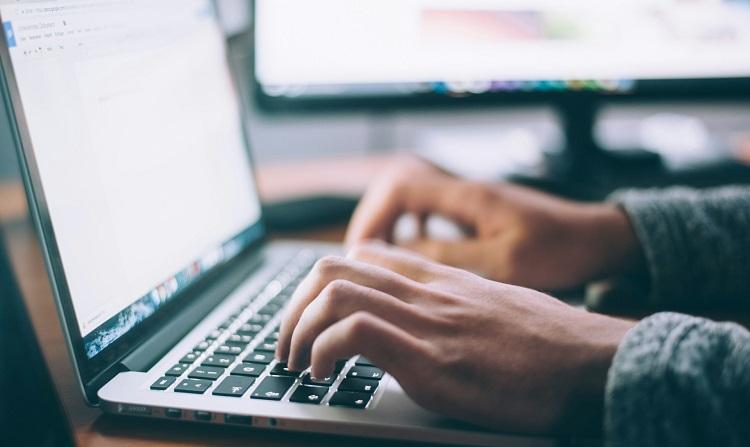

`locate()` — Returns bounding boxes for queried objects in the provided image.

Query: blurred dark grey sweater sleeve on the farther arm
[612,187,750,309]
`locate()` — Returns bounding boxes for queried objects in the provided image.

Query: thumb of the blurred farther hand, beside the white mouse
[402,239,492,274]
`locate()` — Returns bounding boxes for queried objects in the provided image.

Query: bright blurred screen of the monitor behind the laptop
[255,0,750,98]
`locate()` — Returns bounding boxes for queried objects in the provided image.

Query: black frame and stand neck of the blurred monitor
[249,1,750,186]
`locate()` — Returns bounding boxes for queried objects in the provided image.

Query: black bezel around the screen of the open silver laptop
[0,1,267,404]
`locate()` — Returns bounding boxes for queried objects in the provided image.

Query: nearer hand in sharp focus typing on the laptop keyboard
[277,244,632,433]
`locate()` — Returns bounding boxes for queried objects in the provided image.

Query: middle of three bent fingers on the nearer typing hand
[289,279,424,371]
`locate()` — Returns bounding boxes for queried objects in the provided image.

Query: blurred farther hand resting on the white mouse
[347,160,641,290]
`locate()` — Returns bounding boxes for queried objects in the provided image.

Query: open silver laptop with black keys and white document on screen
[0,0,549,445]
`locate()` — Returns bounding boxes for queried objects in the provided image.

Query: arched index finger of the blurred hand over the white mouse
[346,172,481,245]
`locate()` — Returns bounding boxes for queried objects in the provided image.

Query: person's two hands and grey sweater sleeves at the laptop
[277,160,750,446]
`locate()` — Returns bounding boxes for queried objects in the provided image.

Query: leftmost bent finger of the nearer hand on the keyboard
[276,257,428,360]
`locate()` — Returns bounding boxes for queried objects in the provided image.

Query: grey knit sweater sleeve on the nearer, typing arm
[605,313,750,447]
